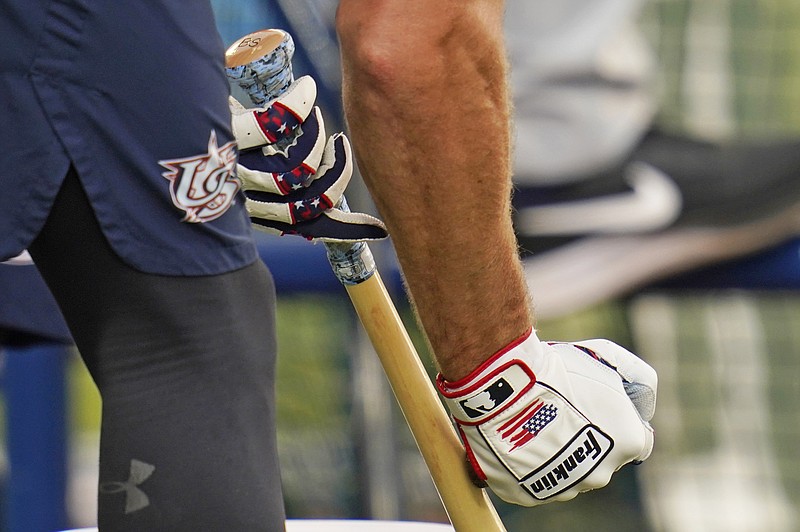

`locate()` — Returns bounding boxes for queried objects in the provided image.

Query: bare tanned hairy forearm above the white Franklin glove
[339,0,531,379]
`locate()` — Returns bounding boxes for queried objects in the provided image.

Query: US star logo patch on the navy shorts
[158,130,239,223]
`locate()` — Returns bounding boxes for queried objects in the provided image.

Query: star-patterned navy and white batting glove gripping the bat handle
[230,76,387,242]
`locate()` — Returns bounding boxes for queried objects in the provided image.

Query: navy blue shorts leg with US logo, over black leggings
[0,0,257,275]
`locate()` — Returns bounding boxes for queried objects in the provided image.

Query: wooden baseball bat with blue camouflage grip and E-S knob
[226,30,505,532]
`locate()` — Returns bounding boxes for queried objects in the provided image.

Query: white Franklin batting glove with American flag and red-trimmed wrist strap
[437,332,658,506]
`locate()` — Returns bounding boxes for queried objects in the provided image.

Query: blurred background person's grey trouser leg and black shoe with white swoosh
[506,0,800,318]
